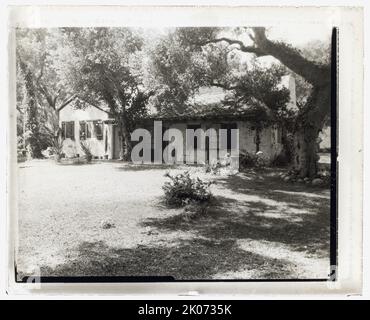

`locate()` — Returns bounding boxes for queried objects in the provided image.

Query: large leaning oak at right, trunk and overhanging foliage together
[147,27,331,177]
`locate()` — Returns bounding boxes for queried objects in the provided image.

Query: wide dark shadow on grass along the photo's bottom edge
[41,238,290,280]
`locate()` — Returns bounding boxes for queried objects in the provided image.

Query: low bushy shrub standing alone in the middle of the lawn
[162,171,212,207]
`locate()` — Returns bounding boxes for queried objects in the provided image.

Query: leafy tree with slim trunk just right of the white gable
[58,28,150,157]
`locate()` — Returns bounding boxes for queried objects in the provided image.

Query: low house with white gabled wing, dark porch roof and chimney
[59,74,295,163]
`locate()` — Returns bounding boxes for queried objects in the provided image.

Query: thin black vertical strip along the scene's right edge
[330,28,339,280]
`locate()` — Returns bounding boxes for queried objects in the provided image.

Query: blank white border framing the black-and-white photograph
[7,6,364,296]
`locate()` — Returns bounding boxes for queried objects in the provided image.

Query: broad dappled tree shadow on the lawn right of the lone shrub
[142,175,330,258]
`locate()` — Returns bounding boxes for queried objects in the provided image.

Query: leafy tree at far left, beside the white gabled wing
[16,29,74,158]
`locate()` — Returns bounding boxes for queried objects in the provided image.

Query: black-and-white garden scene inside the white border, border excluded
[15,25,334,282]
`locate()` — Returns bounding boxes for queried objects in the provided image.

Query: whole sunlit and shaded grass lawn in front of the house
[17,160,330,279]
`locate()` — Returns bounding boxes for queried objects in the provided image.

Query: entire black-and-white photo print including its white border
[0,4,367,298]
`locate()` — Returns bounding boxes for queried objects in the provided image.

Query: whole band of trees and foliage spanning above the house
[16,27,330,176]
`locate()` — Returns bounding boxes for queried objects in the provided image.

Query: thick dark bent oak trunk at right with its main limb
[249,28,331,177]
